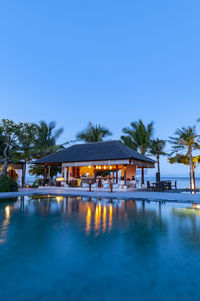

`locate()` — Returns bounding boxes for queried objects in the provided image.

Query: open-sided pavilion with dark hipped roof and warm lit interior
[32,140,155,186]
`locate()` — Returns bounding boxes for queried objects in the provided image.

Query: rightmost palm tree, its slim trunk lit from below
[169,126,200,189]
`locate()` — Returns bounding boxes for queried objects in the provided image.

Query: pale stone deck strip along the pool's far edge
[0,187,200,204]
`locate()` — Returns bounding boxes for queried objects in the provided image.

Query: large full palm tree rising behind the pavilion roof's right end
[121,120,153,186]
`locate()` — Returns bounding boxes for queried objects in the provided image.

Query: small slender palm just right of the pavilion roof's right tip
[150,138,167,181]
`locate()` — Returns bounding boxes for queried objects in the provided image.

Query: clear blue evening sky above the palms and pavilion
[0,0,200,175]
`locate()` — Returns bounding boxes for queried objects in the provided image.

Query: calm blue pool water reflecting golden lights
[0,196,200,301]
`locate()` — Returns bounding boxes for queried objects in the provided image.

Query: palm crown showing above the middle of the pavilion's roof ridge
[76,122,112,143]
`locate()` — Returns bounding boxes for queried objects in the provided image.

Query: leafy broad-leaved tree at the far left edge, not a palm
[0,119,23,176]
